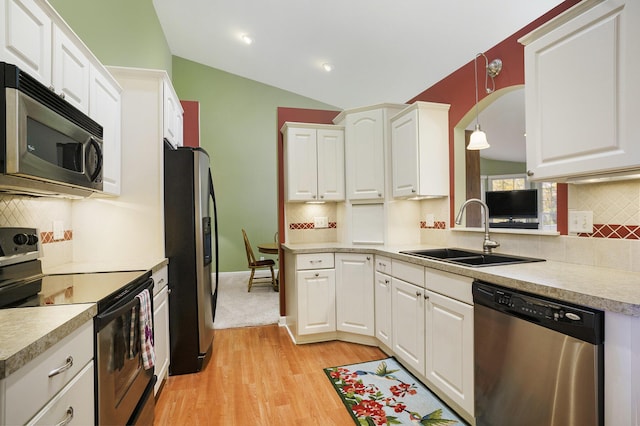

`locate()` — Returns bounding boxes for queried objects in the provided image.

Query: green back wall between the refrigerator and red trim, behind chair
[173,56,339,271]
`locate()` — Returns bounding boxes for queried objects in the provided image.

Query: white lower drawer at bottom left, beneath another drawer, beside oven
[27,361,95,425]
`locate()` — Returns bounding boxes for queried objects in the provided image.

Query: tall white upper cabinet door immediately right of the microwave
[89,67,122,195]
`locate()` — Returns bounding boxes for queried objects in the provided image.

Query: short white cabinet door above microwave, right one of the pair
[51,25,89,113]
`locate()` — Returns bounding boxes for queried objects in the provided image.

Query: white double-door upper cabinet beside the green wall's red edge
[282,123,344,201]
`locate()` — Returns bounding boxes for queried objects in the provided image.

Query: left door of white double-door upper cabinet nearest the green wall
[285,127,318,201]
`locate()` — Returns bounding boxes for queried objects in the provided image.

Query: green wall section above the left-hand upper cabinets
[49,0,172,76]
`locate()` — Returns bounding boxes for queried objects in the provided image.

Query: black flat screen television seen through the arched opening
[485,189,538,219]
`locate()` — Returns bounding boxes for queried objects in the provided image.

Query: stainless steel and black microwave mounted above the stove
[0,62,103,197]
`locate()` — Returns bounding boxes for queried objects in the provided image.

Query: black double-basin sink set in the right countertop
[400,248,544,267]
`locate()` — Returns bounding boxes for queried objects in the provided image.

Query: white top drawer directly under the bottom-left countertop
[5,322,93,424]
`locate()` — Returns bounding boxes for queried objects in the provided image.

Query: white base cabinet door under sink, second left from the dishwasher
[391,278,425,374]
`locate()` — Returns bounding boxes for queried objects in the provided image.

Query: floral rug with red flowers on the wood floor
[324,358,467,426]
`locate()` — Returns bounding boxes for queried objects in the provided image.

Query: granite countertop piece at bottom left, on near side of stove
[0,303,98,379]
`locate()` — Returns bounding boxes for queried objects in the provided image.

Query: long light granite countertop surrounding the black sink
[282,243,640,316]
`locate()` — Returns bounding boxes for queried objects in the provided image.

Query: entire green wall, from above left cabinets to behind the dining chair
[50,0,339,272]
